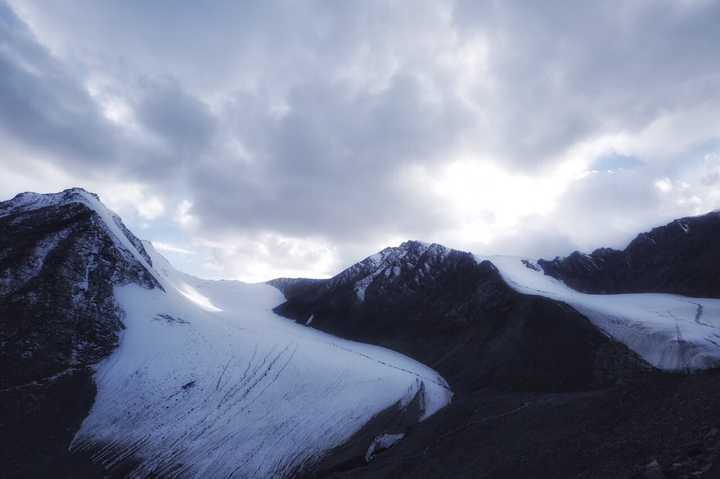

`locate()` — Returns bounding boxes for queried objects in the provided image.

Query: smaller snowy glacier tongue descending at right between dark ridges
[486,256,720,371]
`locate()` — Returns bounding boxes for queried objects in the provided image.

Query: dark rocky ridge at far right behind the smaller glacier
[538,212,720,298]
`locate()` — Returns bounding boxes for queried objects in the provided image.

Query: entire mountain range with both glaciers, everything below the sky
[0,188,720,478]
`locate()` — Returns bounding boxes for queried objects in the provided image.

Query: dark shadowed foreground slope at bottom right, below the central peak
[315,372,720,479]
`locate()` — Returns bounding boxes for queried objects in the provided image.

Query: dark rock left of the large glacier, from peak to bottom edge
[0,189,159,477]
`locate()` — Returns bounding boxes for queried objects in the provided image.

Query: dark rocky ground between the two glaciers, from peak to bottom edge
[276,238,720,478]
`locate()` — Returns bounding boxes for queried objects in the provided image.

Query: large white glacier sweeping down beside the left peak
[72,243,452,477]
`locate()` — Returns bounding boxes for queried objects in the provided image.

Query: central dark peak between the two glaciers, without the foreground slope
[271,241,647,391]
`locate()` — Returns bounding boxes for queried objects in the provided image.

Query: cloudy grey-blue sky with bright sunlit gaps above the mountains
[0,0,720,281]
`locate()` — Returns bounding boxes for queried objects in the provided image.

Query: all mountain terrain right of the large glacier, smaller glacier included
[271,219,720,479]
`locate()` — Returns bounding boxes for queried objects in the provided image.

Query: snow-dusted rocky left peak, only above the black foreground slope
[0,188,161,386]
